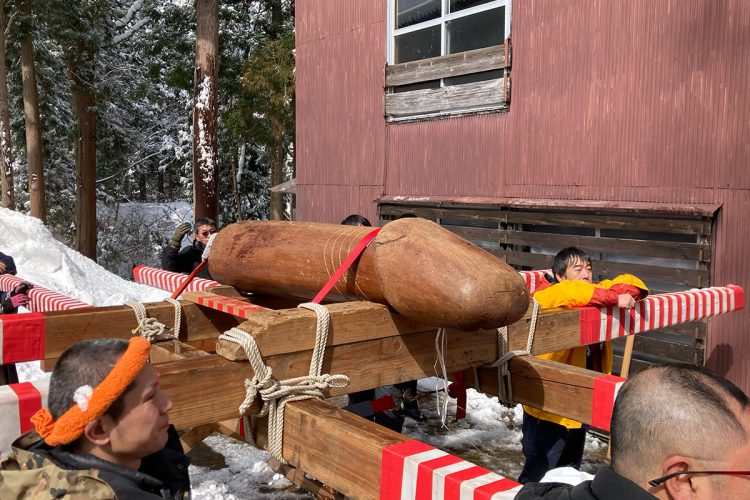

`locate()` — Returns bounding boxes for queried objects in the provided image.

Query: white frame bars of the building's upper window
[386,0,512,68]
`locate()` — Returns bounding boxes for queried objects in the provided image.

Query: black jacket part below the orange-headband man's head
[29,425,190,500]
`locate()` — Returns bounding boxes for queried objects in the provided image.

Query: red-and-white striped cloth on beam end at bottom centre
[380,440,521,500]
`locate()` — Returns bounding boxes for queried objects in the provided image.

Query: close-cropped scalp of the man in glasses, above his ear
[611,365,750,484]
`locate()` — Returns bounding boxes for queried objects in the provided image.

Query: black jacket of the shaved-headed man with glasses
[516,466,656,500]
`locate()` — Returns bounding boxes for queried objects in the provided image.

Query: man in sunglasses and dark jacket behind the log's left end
[161,217,216,279]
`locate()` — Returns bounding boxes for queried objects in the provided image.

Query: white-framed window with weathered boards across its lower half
[386,0,510,119]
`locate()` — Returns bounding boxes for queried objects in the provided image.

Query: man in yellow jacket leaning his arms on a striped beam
[518,247,648,483]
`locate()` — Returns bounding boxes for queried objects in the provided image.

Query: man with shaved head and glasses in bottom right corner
[516,365,750,500]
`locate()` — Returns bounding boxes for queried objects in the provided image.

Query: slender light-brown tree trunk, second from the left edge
[21,0,47,222]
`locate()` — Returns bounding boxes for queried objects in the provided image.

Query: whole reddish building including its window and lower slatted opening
[296,0,750,390]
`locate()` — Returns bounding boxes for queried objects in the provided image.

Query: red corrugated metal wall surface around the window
[297,0,750,389]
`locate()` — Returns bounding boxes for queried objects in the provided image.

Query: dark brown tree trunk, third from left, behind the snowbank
[71,89,96,260]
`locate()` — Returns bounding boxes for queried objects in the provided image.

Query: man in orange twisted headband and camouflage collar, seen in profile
[0,337,190,499]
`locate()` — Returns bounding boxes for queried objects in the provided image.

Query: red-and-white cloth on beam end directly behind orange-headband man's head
[0,379,49,458]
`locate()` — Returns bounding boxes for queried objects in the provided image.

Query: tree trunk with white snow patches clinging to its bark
[193,0,219,220]
